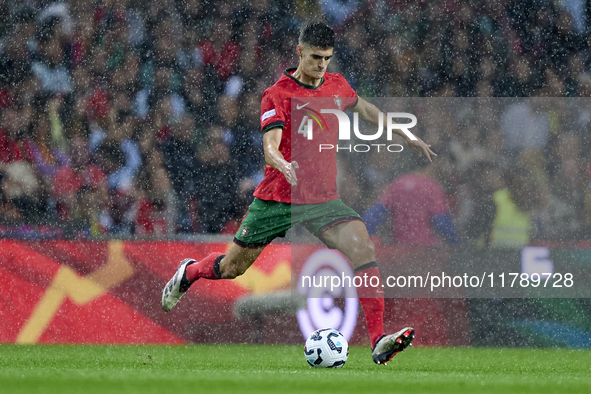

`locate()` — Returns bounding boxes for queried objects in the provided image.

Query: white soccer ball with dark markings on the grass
[304,328,349,368]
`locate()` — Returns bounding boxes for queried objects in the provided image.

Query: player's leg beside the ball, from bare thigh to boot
[322,220,414,364]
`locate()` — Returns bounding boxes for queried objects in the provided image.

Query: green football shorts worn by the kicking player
[234,197,362,248]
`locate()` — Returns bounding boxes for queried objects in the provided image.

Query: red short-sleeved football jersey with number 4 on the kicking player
[254,68,357,204]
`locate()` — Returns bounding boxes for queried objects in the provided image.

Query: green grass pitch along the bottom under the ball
[0,345,591,394]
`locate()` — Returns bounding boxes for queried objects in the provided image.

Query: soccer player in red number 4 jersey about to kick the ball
[162,23,435,364]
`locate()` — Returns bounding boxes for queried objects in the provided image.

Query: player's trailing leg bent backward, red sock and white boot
[161,243,264,312]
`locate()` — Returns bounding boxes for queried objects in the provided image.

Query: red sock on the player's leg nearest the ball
[355,261,384,349]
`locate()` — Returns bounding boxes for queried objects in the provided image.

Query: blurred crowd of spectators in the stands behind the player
[0,0,591,244]
